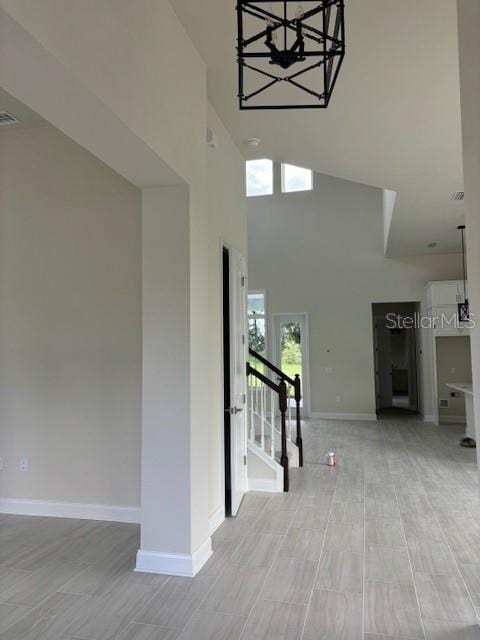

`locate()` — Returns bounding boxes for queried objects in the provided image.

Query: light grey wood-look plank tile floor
[0,418,480,640]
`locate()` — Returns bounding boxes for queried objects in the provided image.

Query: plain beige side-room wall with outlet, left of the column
[0,127,141,506]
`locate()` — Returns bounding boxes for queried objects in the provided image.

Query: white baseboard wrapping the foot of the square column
[135,537,212,578]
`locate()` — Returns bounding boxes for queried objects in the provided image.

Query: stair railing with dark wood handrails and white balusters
[247,349,303,491]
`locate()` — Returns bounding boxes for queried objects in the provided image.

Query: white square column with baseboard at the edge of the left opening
[137,186,211,575]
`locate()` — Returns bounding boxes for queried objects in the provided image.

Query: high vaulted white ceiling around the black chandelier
[171,0,464,256]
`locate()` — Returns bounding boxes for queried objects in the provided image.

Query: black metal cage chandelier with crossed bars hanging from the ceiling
[237,0,345,109]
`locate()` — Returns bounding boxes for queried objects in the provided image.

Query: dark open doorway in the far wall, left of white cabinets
[372,302,419,414]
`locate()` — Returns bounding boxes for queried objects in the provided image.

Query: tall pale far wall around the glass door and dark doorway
[247,174,460,415]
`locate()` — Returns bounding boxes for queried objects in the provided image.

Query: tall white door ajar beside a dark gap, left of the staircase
[222,246,247,516]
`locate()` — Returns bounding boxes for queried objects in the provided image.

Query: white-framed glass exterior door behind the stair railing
[273,313,310,416]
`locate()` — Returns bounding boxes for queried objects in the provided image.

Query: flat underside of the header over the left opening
[0,9,183,188]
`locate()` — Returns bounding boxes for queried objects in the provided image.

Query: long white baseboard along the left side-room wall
[0,498,140,524]
